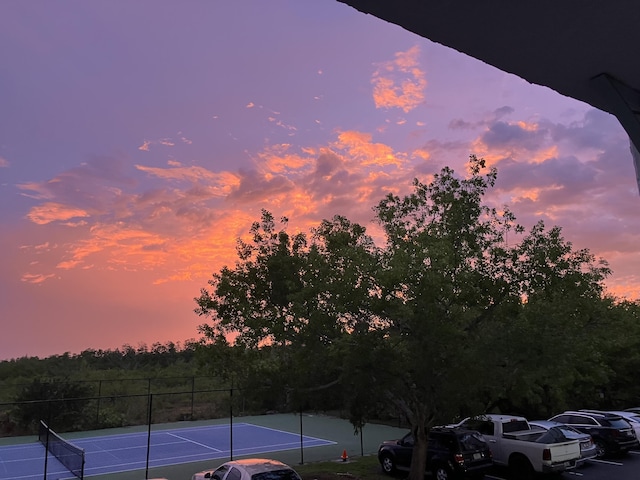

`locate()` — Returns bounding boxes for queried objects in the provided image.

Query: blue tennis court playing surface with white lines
[0,423,335,480]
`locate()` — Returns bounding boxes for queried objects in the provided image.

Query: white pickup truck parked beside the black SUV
[458,414,580,478]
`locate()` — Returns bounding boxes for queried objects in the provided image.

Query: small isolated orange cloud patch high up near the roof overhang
[371,46,427,112]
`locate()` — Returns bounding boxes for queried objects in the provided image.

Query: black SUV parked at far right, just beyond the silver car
[549,410,638,457]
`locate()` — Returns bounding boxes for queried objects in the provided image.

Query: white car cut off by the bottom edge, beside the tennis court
[191,458,302,480]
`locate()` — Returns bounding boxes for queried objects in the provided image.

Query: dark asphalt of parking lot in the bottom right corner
[484,451,640,480]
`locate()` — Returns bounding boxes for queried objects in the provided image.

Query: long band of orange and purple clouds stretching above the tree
[11,107,640,304]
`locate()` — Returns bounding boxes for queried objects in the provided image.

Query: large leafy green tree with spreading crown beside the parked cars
[196,156,609,480]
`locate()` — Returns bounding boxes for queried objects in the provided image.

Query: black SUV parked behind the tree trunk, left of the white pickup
[378,427,493,480]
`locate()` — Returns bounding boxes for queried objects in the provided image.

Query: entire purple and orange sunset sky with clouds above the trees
[0,0,640,360]
